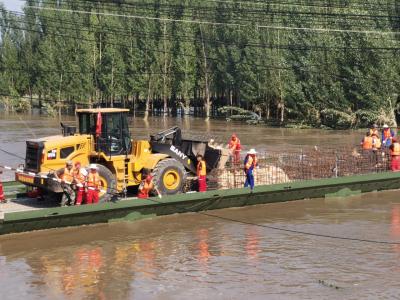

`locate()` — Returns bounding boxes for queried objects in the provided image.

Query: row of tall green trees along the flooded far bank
[0,0,400,128]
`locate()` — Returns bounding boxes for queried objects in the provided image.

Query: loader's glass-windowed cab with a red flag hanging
[76,108,132,156]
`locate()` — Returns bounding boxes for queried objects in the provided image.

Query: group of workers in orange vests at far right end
[361,124,400,171]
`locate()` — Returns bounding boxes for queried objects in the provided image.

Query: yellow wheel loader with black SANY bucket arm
[16,108,228,202]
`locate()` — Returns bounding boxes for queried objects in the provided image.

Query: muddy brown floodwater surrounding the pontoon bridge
[0,115,400,300]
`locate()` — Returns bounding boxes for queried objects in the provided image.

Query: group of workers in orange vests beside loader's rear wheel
[54,161,101,206]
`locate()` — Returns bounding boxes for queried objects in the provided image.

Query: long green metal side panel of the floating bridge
[0,172,400,234]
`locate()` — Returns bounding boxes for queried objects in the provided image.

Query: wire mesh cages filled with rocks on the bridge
[208,146,390,189]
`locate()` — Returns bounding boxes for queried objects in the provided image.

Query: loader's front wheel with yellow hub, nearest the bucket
[152,158,186,195]
